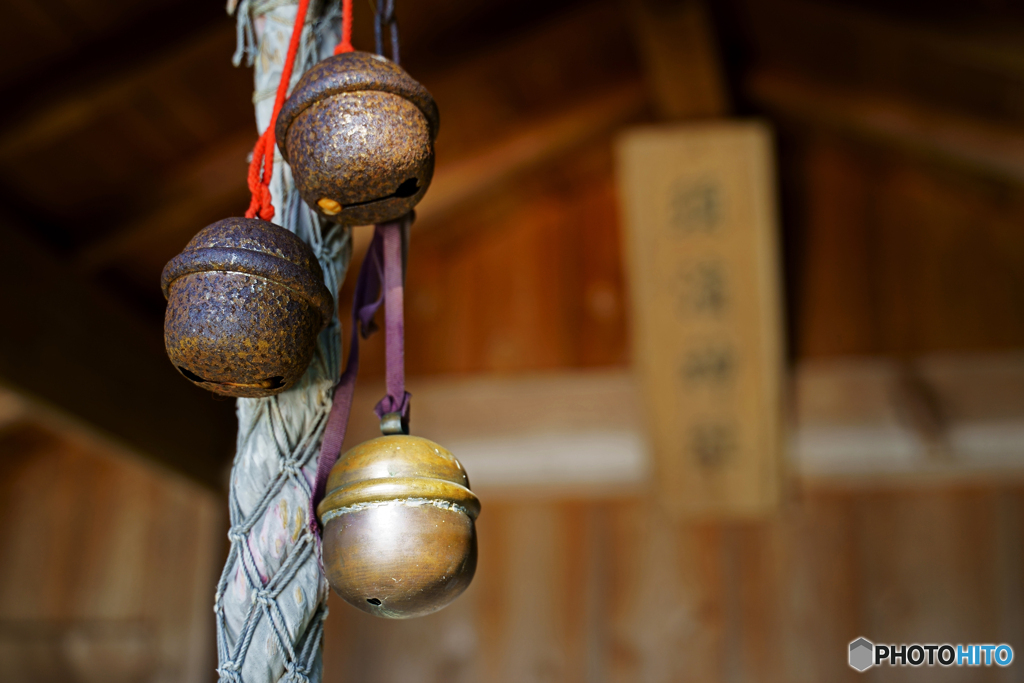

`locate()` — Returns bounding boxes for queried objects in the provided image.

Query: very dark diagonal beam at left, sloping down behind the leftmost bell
[0,216,234,487]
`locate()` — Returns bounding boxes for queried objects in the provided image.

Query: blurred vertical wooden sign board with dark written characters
[617,122,783,516]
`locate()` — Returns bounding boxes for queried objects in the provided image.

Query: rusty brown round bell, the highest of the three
[274,51,438,225]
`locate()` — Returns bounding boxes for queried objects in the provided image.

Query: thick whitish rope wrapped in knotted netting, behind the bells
[214,0,351,683]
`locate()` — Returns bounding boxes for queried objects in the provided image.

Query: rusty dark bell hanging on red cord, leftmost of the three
[161,218,334,397]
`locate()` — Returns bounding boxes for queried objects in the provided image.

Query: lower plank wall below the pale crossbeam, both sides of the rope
[0,411,1024,683]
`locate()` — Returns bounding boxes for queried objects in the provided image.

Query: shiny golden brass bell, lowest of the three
[316,434,480,618]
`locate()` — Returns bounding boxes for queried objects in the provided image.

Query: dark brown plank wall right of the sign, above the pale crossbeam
[788,133,1024,357]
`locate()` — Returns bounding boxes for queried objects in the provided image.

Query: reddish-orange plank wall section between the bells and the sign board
[348,139,629,381]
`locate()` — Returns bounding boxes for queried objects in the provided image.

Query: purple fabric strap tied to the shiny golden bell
[309,215,412,531]
